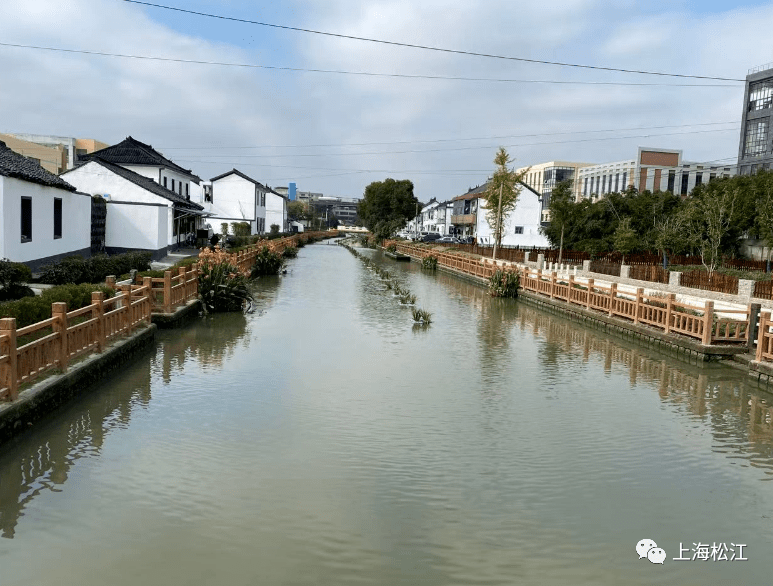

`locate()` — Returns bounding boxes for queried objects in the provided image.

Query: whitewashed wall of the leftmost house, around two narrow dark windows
[0,176,91,268]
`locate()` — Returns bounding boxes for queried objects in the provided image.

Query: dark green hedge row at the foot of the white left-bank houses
[40,252,151,285]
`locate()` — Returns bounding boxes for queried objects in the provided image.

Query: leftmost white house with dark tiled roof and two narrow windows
[0,142,91,270]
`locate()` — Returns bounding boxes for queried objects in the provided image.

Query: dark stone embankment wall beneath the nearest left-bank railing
[0,324,157,444]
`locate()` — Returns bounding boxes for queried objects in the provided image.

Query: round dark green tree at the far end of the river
[357,179,418,240]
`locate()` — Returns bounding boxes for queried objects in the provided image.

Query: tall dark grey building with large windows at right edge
[738,63,773,175]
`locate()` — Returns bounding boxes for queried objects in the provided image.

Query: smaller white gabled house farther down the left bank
[204,169,269,234]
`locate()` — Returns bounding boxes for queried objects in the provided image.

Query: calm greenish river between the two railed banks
[0,243,773,586]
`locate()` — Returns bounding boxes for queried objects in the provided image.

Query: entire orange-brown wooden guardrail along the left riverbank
[0,232,335,401]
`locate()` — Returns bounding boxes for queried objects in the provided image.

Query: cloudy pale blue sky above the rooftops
[0,0,773,201]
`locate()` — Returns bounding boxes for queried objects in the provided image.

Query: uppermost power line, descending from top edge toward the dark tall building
[123,0,746,82]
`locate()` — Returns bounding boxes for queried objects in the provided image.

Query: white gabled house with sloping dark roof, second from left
[62,159,203,258]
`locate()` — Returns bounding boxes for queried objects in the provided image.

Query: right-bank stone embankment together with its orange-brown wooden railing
[386,242,773,383]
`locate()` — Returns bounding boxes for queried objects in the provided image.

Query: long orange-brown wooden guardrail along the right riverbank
[389,242,756,360]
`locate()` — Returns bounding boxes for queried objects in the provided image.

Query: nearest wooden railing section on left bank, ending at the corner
[0,277,152,401]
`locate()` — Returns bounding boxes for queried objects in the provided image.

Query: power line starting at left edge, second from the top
[0,41,738,88]
